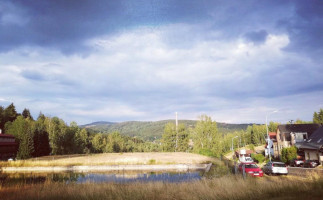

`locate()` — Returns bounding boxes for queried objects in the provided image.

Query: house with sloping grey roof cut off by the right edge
[300,126,323,165]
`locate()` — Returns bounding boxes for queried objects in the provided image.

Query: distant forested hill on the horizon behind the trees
[81,120,251,141]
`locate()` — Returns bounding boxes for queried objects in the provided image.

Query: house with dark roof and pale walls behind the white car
[273,124,320,158]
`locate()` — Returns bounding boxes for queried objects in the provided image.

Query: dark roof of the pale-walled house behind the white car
[278,124,320,136]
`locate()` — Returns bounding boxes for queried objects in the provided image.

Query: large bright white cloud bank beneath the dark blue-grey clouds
[0,24,322,123]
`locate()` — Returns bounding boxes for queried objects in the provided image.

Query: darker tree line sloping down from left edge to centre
[0,104,161,159]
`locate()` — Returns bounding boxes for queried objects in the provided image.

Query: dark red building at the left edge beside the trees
[0,129,18,160]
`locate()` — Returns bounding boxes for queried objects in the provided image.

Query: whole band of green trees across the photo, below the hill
[0,103,323,159]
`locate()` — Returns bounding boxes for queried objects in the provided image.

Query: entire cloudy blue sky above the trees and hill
[0,0,323,124]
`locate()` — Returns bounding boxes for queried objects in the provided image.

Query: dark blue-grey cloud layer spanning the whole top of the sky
[0,0,323,58]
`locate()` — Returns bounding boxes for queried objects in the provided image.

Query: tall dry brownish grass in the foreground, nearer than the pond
[0,175,323,200]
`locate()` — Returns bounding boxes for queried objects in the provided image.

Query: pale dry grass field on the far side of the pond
[0,152,216,167]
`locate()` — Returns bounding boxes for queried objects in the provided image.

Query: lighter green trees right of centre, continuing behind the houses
[161,109,323,157]
